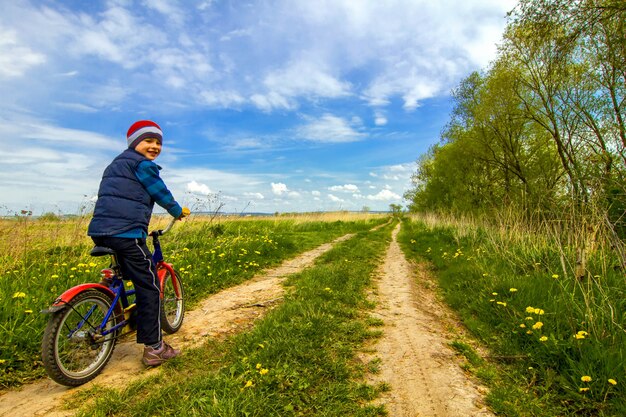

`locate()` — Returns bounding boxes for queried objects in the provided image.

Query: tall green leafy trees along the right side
[405,0,626,237]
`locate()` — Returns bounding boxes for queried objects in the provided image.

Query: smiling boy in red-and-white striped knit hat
[87,120,189,366]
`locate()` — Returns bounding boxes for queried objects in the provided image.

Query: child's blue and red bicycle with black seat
[41,219,185,387]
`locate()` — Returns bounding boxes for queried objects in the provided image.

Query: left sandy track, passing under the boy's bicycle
[0,234,353,417]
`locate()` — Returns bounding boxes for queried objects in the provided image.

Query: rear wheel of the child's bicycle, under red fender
[41,290,117,387]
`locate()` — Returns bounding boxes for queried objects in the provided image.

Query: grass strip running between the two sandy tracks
[64,219,392,417]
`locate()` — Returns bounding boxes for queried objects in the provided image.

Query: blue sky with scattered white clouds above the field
[0,0,515,215]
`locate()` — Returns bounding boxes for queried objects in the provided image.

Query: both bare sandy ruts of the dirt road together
[0,228,490,417]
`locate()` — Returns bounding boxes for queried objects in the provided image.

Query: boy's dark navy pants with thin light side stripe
[92,236,162,345]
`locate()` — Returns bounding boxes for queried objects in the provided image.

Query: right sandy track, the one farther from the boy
[369,226,493,417]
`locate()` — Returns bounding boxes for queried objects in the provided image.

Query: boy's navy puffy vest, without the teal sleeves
[87,149,154,236]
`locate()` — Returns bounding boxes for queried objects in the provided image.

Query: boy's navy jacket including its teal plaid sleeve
[87,148,182,238]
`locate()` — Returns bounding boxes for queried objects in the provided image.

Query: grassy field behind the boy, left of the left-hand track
[0,213,387,388]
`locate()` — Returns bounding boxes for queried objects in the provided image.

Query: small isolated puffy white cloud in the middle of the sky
[296,114,365,143]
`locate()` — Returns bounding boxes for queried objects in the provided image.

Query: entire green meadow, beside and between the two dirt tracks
[0,214,626,417]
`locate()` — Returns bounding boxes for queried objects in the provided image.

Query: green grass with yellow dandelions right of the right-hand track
[399,216,626,416]
